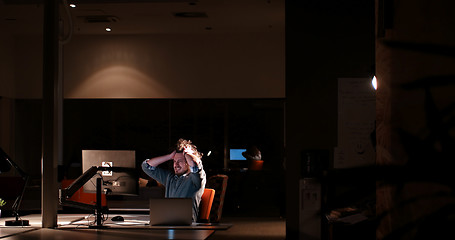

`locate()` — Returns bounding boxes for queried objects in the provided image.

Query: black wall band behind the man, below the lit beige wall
[63,99,284,177]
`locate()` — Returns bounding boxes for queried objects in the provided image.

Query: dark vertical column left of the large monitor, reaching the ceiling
[41,0,62,228]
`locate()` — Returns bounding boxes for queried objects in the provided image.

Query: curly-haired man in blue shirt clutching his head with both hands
[142,139,206,222]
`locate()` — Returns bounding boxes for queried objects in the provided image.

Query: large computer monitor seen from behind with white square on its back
[82,150,139,195]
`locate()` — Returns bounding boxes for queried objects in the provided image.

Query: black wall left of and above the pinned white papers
[286,0,375,239]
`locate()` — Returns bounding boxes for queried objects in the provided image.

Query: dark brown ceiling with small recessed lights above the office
[0,0,285,35]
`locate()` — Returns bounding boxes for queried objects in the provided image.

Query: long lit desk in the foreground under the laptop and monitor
[0,214,230,240]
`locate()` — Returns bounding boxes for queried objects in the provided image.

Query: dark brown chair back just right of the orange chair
[206,174,228,222]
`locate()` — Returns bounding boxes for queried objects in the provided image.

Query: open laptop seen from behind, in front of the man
[150,198,193,226]
